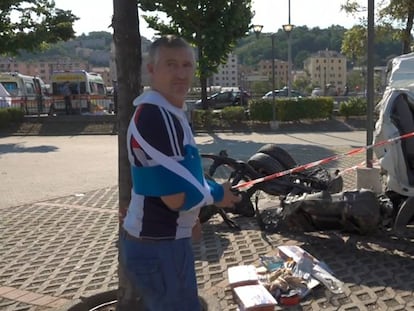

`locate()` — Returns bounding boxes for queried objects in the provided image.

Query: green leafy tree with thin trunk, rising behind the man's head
[140,0,253,107]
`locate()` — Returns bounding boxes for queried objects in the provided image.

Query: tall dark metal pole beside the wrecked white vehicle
[366,0,374,168]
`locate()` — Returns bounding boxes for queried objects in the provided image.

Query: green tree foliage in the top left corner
[0,0,78,55]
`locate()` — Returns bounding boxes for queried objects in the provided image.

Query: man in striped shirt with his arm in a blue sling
[120,35,240,311]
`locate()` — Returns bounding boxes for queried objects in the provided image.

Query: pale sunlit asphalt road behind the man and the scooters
[0,131,366,208]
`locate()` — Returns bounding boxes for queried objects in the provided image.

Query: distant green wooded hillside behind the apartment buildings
[11,25,401,68]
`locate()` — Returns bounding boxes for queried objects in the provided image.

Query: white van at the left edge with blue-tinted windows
[0,72,51,114]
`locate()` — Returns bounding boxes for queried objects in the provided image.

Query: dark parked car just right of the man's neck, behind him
[195,91,250,109]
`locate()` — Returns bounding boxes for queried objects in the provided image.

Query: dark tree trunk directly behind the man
[112,0,142,311]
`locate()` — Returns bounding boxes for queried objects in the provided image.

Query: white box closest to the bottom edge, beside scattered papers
[234,284,277,311]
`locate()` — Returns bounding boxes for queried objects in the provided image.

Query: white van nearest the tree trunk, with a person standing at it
[51,70,113,114]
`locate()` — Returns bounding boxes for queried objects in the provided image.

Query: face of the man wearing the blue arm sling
[148,47,195,108]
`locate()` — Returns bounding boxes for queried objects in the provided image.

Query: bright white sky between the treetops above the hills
[55,0,364,40]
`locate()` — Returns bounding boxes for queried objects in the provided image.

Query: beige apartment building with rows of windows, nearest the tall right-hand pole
[304,50,347,94]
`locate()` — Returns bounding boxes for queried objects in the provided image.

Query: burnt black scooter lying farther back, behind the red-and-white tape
[200,144,343,229]
